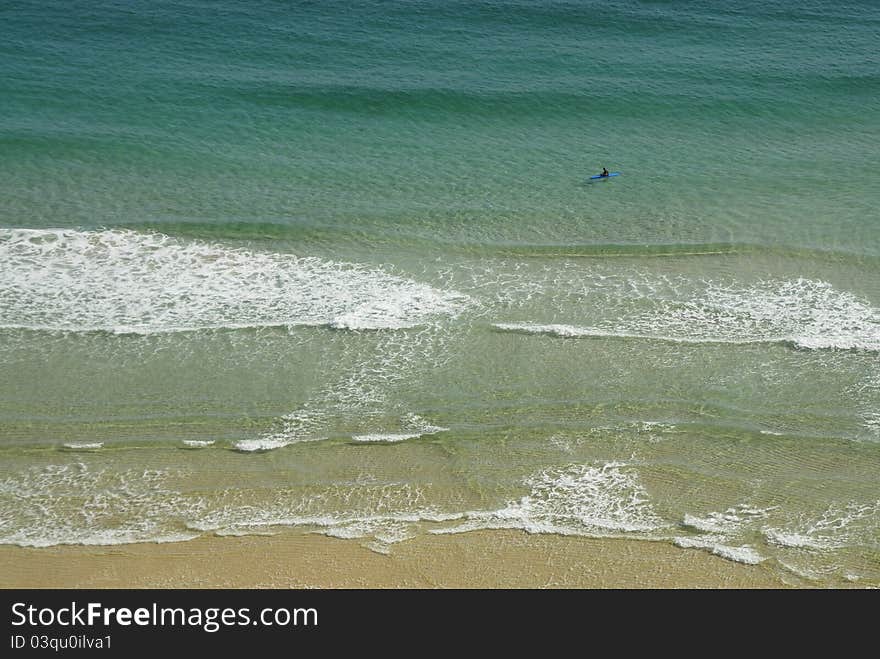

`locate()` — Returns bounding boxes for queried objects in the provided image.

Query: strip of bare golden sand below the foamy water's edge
[0,530,793,589]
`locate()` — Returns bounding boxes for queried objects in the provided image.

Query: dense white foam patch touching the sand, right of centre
[433,462,664,535]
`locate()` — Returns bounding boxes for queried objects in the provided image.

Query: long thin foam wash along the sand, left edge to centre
[0,464,468,553]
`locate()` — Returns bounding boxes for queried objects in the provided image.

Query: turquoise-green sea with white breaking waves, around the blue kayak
[0,0,880,586]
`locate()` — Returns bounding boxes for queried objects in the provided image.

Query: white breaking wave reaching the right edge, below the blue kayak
[493,279,880,351]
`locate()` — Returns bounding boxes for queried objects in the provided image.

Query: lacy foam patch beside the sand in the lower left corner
[0,464,203,547]
